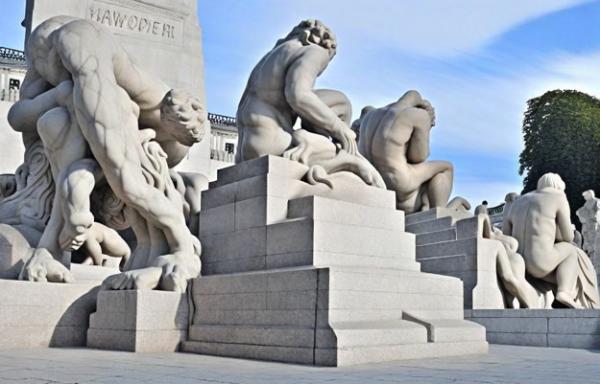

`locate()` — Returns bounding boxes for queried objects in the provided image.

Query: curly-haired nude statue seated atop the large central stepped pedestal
[236,20,385,188]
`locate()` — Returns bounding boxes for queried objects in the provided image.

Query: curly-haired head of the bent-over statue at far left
[160,89,208,146]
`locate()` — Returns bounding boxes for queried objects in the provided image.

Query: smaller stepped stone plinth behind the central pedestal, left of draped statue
[406,208,505,309]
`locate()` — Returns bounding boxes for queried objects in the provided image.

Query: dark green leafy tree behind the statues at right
[519,90,600,223]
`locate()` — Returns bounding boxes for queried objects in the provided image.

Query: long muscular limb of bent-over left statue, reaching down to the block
[74,76,200,289]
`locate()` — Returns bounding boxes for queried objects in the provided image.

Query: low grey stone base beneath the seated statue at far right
[465,309,600,349]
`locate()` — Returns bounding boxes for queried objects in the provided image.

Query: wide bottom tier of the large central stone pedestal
[183,267,487,366]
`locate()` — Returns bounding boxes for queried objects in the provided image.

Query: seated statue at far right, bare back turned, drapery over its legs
[502,173,600,308]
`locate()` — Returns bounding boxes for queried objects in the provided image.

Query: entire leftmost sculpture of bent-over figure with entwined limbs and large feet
[0,16,206,291]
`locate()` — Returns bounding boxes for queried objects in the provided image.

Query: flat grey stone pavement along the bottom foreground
[0,345,600,384]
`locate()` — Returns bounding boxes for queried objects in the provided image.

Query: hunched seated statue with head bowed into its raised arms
[353,91,470,214]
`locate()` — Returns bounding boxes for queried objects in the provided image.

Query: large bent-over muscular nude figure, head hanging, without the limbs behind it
[11,16,206,291]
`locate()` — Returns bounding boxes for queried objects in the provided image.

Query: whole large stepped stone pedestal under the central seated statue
[183,157,487,366]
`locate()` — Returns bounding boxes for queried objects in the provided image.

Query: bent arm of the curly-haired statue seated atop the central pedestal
[285,45,350,137]
